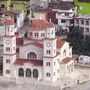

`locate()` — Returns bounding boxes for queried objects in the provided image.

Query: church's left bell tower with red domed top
[3,19,16,77]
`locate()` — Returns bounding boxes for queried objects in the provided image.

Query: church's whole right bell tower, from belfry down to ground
[43,23,57,82]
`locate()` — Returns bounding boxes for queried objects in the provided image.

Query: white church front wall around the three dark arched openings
[13,63,43,80]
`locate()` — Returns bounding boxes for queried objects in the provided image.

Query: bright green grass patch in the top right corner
[75,0,90,15]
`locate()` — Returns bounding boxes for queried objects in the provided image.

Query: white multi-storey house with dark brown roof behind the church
[49,2,77,31]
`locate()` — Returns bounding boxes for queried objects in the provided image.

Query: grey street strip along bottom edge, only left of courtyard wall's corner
[0,82,60,90]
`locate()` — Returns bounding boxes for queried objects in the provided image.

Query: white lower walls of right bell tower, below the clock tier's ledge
[43,55,60,82]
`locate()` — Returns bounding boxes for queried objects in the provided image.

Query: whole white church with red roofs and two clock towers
[3,19,74,82]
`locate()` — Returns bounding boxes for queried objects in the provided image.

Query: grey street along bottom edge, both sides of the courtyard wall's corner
[0,81,90,90]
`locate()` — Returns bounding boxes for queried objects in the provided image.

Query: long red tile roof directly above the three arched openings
[13,58,43,66]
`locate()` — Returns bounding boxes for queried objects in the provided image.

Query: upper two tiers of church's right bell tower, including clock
[44,28,56,57]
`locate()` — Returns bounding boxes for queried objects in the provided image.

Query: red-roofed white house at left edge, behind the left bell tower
[0,9,25,27]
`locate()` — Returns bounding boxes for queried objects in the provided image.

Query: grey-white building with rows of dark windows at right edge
[74,15,90,36]
